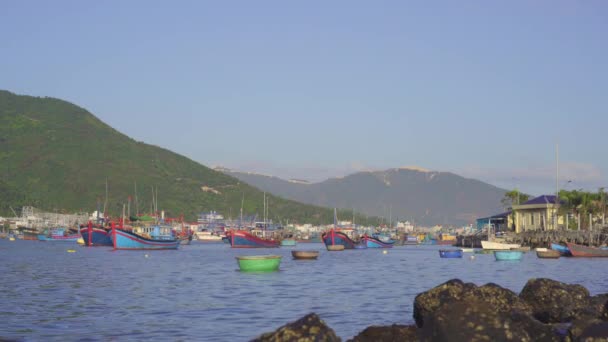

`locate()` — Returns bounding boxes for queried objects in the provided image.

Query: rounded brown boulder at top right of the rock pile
[519,278,591,323]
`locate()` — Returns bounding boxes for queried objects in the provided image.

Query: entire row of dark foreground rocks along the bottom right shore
[253,278,608,342]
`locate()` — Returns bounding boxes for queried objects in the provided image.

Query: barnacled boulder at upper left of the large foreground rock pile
[414,279,532,328]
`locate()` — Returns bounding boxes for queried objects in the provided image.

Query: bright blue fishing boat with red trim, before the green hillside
[112,223,180,250]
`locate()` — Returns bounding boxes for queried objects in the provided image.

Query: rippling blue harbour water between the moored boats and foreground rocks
[0,240,608,341]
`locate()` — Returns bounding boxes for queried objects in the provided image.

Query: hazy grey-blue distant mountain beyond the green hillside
[222,168,506,226]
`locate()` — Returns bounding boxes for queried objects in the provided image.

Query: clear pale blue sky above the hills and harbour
[0,0,608,195]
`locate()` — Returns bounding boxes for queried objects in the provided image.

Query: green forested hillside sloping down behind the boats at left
[0,91,376,223]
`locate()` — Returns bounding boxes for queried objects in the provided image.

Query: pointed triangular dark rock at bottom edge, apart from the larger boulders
[252,313,340,342]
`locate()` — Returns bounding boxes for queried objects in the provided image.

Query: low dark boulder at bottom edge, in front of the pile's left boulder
[421,298,561,342]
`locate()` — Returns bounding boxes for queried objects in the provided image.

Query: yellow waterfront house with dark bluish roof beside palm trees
[513,195,564,233]
